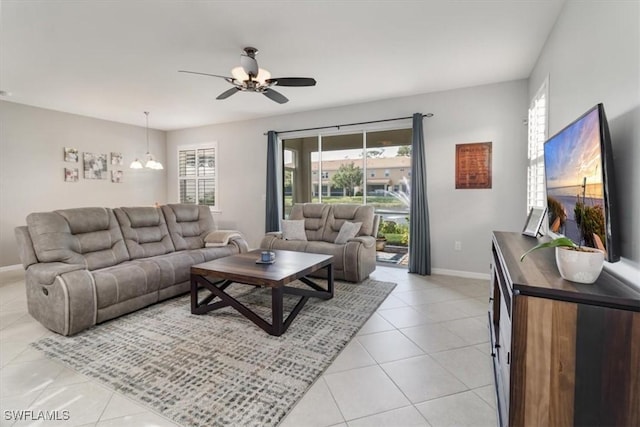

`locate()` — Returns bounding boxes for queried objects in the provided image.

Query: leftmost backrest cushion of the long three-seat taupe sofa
[27,208,129,270]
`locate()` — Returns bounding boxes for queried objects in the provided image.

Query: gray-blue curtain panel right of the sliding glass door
[409,113,431,275]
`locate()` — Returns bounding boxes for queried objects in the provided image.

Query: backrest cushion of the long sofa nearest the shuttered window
[162,204,216,251]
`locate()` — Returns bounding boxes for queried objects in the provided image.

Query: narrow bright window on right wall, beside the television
[527,80,549,212]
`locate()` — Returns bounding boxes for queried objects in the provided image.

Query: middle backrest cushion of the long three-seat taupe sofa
[113,206,175,259]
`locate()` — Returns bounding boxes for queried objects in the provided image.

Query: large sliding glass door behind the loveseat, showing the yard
[282,129,412,265]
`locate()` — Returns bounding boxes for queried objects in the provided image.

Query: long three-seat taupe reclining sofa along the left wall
[16,204,248,335]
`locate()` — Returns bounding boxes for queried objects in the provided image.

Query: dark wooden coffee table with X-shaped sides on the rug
[191,250,333,336]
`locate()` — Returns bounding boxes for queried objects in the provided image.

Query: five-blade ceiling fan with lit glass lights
[178,47,316,104]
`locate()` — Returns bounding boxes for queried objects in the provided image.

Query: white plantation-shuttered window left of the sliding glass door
[178,144,218,208]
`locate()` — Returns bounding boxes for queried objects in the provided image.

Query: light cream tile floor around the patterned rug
[0,267,496,427]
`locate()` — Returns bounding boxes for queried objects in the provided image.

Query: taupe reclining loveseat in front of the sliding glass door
[260,203,379,282]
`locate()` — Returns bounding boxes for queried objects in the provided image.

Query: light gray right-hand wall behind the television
[529,1,640,286]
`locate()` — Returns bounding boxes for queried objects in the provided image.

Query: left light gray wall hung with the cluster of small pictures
[0,101,166,267]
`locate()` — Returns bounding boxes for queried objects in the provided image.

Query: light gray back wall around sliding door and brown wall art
[167,80,527,274]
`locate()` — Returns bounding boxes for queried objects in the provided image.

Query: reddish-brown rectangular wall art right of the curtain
[456,142,491,189]
